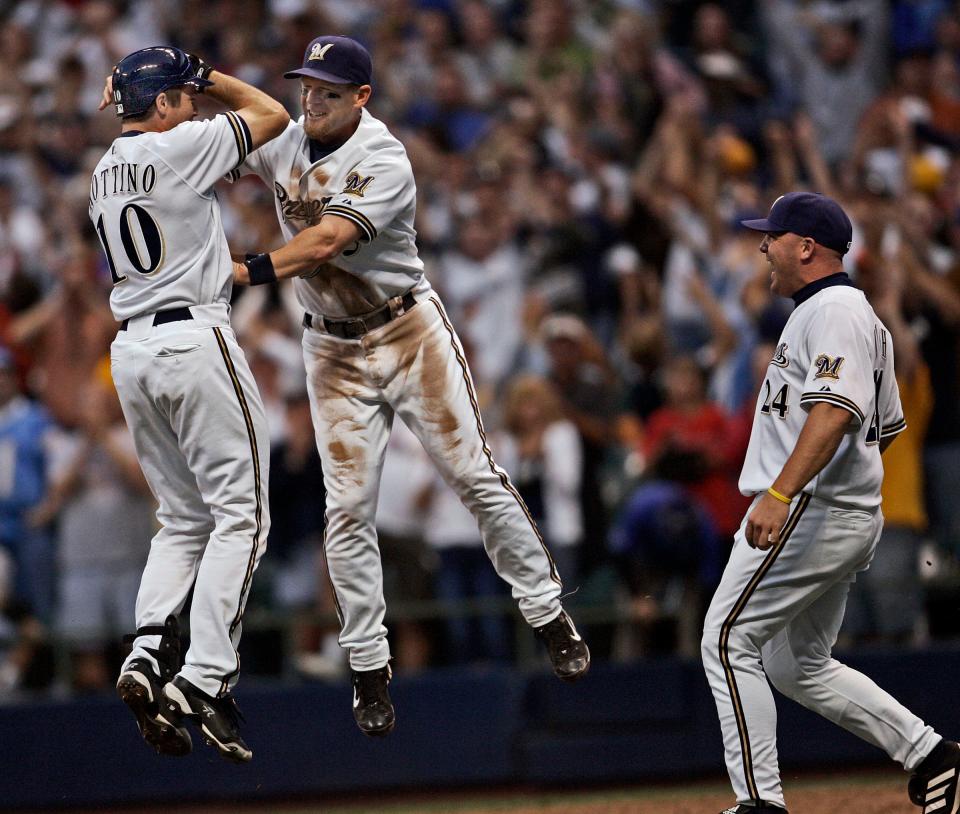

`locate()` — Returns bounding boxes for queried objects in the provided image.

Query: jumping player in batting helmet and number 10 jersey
[90,47,290,762]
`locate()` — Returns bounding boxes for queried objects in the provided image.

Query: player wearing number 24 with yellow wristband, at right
[702,192,960,814]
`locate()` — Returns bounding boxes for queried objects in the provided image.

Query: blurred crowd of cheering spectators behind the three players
[0,0,960,696]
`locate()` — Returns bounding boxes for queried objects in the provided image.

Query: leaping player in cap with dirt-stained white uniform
[231,36,590,736]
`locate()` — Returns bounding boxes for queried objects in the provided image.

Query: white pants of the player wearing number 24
[702,494,940,805]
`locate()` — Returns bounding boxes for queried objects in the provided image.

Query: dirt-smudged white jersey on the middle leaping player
[231,109,430,317]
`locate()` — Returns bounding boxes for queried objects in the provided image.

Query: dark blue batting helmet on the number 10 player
[113,45,213,118]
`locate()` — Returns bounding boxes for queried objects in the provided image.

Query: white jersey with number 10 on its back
[89,112,252,321]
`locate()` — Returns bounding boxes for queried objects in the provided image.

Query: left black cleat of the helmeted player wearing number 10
[117,614,193,757]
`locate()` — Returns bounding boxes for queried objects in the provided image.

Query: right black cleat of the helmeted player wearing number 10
[163,676,253,763]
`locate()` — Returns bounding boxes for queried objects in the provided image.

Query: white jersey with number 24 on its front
[740,285,906,508]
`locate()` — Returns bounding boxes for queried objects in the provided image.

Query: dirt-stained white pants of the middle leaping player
[303,295,560,670]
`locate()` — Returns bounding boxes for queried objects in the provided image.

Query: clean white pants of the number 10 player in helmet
[112,305,270,695]
